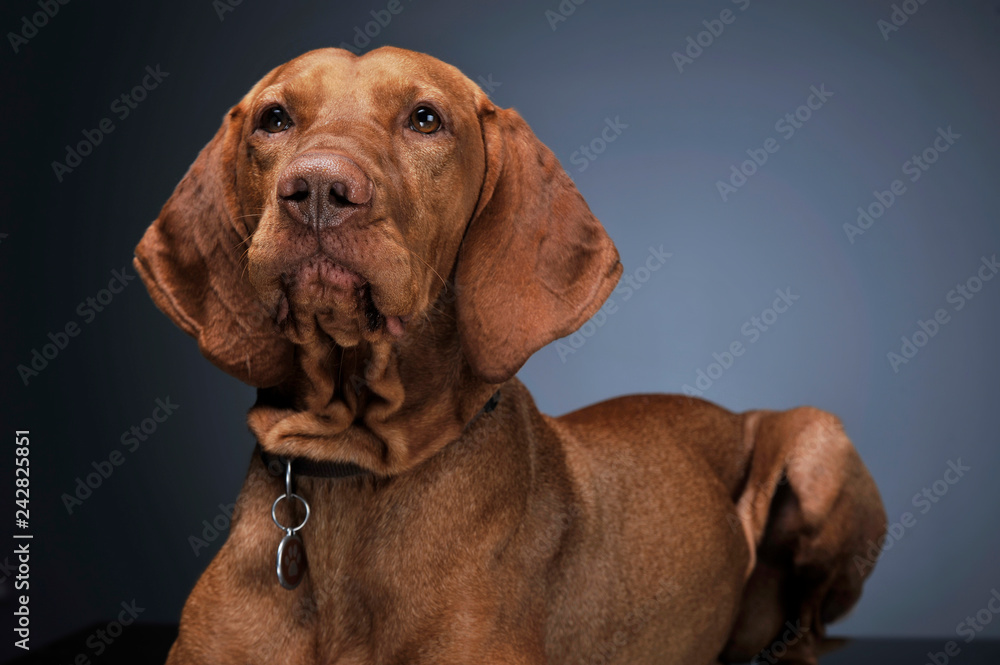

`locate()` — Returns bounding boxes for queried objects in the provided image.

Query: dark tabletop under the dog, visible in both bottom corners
[3,624,1000,665]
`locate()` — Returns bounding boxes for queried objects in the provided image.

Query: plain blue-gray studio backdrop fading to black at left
[0,0,1000,655]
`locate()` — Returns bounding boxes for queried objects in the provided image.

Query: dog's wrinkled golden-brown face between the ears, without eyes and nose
[236,50,487,347]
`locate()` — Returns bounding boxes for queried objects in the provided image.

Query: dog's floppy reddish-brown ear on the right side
[455,105,622,383]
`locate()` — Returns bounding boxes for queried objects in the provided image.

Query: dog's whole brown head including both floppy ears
[136,48,621,466]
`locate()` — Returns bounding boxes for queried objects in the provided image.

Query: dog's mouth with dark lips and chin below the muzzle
[274,254,410,339]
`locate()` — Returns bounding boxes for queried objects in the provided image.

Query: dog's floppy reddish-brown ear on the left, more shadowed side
[133,107,293,388]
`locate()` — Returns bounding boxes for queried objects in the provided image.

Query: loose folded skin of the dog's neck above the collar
[248,294,498,476]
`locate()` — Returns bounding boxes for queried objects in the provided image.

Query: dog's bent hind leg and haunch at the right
[722,407,886,664]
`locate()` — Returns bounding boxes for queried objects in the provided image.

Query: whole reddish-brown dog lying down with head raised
[135,48,885,665]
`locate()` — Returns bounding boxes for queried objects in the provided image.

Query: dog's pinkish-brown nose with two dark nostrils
[278,152,372,228]
